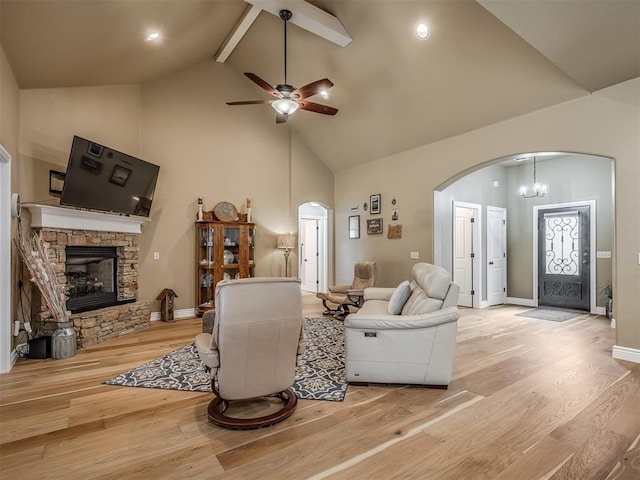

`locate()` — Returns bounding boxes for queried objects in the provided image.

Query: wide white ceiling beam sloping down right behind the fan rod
[245,0,352,47]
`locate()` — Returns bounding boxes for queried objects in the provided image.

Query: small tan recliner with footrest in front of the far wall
[316,262,377,318]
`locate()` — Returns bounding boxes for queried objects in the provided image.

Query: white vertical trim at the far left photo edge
[0,145,15,373]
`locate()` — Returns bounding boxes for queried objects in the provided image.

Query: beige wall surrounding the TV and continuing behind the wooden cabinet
[18,61,333,316]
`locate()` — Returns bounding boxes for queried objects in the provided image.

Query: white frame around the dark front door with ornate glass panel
[531,200,597,313]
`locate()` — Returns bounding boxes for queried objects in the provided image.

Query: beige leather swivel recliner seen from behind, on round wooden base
[195,278,306,430]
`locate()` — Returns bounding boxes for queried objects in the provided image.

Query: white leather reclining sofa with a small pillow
[345,263,460,388]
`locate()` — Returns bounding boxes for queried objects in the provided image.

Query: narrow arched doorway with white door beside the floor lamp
[298,202,328,293]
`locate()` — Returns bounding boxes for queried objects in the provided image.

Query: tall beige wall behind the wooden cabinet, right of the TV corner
[140,61,333,309]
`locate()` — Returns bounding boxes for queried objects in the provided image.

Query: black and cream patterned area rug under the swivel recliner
[103,318,347,402]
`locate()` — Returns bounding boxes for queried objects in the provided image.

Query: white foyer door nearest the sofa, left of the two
[453,206,475,307]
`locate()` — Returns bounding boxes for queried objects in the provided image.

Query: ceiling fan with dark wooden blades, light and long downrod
[227,10,338,123]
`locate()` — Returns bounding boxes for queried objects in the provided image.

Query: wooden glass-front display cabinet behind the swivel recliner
[196,222,255,316]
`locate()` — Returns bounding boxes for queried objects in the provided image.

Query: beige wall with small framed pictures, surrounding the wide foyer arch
[334,79,640,349]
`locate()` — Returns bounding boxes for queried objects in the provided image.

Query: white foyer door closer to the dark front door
[487,207,507,306]
